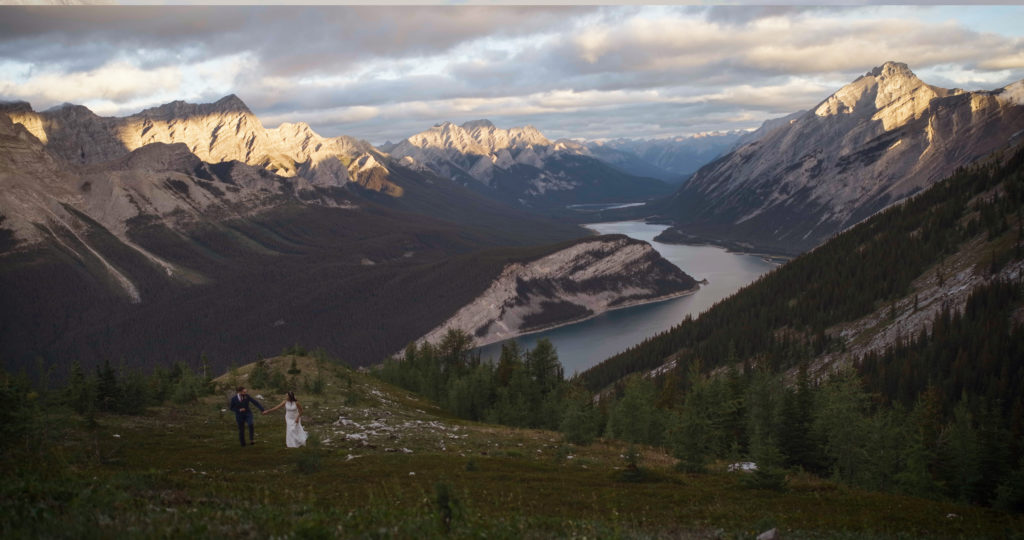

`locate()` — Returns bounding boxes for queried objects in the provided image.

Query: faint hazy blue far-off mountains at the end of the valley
[587,131,746,183]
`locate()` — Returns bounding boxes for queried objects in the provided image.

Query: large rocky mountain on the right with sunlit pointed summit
[656,63,1024,254]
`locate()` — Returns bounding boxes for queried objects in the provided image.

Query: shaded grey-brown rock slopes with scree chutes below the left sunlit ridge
[0,110,331,302]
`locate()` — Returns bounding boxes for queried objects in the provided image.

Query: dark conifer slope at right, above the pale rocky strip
[582,144,1024,390]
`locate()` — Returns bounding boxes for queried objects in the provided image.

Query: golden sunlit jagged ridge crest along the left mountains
[0,95,402,197]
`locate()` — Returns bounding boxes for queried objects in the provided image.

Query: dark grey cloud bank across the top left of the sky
[0,6,593,76]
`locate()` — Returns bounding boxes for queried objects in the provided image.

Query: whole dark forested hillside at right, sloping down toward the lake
[552,142,1024,509]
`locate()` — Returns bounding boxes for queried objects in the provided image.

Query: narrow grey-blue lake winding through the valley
[480,221,777,377]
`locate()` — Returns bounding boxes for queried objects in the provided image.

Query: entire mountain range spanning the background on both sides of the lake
[6,63,1024,381]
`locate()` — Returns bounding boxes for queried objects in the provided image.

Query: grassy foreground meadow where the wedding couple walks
[0,357,1024,538]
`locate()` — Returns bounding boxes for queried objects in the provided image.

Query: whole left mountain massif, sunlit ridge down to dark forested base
[0,96,696,376]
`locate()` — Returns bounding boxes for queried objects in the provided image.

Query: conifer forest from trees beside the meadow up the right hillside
[378,144,1024,511]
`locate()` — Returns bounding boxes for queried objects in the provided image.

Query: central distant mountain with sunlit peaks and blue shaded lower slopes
[382,120,671,209]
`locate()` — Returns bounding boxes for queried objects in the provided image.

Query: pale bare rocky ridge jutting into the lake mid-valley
[422,236,698,345]
